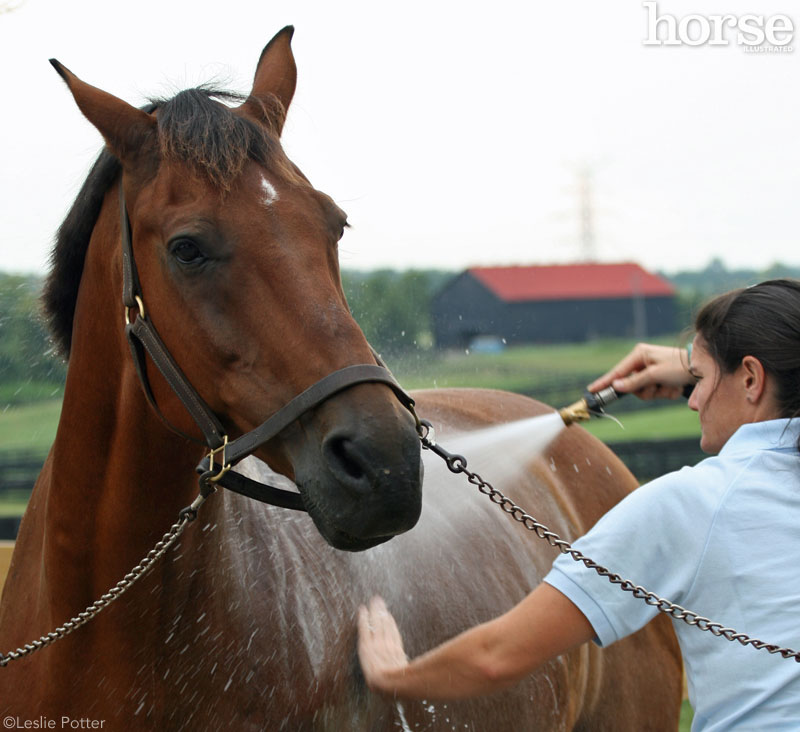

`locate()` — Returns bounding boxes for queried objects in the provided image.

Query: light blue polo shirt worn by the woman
[544,419,800,732]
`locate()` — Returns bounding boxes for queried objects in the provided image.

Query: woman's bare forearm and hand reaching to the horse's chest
[358,584,595,700]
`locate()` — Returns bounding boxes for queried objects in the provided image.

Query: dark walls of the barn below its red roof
[431,272,676,348]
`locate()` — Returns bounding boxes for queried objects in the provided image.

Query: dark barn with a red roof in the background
[431,262,676,348]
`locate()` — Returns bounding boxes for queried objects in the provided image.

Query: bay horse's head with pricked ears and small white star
[51,28,422,550]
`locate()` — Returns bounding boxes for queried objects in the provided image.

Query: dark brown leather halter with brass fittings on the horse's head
[119,186,423,511]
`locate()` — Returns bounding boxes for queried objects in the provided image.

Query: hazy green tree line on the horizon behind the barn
[0,259,800,409]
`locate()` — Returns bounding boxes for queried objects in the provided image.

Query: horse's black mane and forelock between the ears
[42,86,288,358]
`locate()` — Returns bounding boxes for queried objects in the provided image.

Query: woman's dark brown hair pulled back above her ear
[695,279,800,426]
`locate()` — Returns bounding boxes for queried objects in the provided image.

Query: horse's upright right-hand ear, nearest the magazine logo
[242,25,297,134]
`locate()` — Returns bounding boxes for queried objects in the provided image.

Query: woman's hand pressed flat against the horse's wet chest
[358,597,408,693]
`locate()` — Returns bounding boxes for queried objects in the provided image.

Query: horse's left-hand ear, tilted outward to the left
[50,59,157,163]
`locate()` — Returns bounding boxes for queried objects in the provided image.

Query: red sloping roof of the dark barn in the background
[467,262,675,302]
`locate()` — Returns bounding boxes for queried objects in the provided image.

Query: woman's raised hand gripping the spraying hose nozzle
[588,343,694,399]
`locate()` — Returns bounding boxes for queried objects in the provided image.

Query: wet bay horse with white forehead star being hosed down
[0,28,680,732]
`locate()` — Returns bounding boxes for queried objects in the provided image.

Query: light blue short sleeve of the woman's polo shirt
[544,461,717,646]
